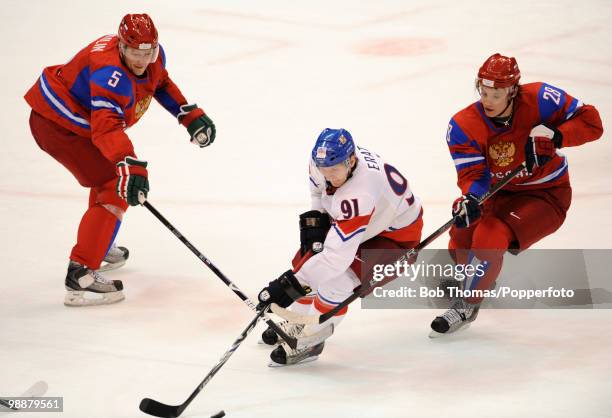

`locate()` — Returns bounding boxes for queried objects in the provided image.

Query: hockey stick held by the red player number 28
[271,162,525,325]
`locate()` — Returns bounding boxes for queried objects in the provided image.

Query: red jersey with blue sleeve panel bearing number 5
[25,35,192,163]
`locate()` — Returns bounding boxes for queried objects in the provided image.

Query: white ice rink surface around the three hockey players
[0,0,612,418]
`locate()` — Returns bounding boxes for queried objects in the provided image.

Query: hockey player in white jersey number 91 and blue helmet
[259,129,423,366]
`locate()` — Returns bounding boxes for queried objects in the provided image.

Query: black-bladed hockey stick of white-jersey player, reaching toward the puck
[139,306,268,418]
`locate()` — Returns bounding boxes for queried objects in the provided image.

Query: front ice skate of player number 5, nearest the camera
[64,261,125,306]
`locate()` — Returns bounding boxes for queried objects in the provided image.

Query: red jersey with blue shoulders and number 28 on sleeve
[446,83,603,196]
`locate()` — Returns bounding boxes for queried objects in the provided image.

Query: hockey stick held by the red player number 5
[139,197,297,349]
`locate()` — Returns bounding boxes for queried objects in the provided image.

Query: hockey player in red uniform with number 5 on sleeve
[25,14,215,306]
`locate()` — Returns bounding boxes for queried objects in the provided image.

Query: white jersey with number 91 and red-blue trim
[295,147,422,288]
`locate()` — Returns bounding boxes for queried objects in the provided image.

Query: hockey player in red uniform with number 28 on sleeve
[431,54,603,337]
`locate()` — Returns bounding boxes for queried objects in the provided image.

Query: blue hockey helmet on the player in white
[312,128,355,167]
